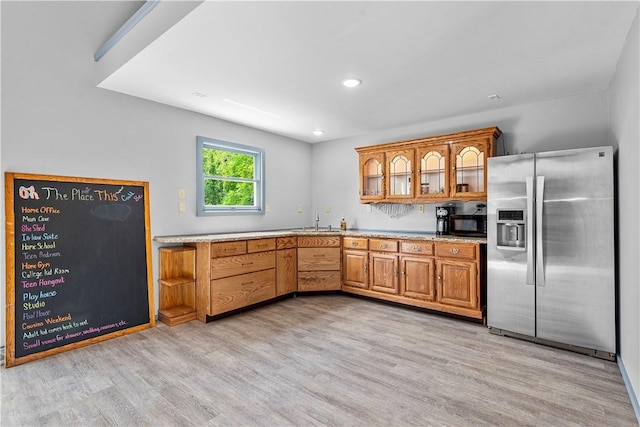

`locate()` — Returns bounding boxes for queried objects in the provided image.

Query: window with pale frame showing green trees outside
[196,136,264,216]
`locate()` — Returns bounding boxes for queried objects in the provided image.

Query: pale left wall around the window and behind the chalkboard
[0,2,312,345]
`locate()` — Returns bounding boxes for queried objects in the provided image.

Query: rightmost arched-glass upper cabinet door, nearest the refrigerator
[452,142,487,197]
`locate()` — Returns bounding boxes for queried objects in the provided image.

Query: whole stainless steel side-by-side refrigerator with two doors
[487,146,616,360]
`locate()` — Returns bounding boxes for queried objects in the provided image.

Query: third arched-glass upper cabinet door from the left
[416,145,449,198]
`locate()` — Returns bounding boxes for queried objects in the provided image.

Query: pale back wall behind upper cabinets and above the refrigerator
[312,92,609,236]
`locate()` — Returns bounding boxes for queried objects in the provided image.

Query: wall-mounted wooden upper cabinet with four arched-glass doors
[356,127,502,203]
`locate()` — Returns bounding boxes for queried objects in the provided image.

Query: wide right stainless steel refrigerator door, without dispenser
[536,147,616,353]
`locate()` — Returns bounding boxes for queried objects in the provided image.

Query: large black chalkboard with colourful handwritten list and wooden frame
[5,172,155,367]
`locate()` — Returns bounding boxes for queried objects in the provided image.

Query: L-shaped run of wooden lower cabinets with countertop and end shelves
[154,228,486,325]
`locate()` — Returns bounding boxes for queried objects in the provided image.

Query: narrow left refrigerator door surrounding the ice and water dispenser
[487,154,536,337]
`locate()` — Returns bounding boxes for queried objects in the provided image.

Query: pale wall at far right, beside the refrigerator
[610,7,640,416]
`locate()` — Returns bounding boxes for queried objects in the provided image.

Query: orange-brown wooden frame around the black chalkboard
[4,172,155,368]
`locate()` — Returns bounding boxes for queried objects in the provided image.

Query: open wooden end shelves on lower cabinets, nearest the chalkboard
[158,246,196,326]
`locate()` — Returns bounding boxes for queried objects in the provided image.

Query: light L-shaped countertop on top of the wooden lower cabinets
[153,231,487,244]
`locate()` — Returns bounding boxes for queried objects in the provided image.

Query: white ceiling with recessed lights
[99,1,638,142]
